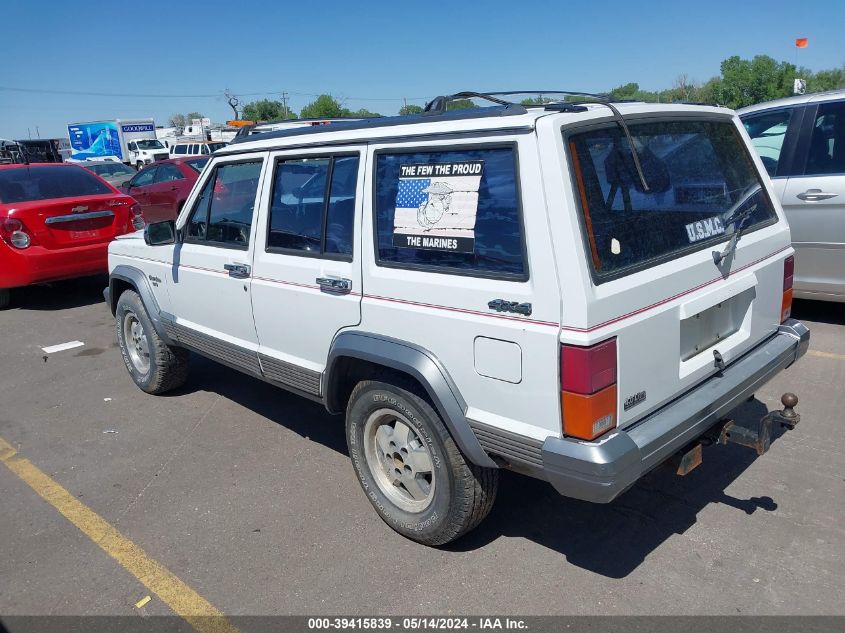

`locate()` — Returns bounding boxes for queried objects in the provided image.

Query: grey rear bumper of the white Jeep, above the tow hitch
[542,319,810,503]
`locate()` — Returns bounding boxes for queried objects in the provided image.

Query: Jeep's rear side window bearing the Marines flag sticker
[375,146,528,278]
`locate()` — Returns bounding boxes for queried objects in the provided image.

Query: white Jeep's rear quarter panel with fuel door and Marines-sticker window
[361,139,562,444]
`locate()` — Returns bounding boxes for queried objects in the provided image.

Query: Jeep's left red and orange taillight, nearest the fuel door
[560,338,617,440]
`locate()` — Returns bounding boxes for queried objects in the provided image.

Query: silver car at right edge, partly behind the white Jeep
[739,90,845,302]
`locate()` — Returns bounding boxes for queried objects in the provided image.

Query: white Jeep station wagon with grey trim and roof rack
[105,93,809,545]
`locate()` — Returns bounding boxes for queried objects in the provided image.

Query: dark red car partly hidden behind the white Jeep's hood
[121,156,208,224]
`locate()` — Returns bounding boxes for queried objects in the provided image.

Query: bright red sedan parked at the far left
[0,163,144,309]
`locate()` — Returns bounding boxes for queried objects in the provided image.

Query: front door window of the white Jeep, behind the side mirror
[186,160,262,248]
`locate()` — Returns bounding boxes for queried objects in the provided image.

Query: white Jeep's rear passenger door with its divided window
[246,147,364,395]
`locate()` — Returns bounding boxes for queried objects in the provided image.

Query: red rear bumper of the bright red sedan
[0,242,109,288]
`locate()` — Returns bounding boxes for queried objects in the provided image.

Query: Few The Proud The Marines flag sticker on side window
[393,160,484,253]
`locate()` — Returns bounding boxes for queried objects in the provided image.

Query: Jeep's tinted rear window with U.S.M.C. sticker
[565,120,776,283]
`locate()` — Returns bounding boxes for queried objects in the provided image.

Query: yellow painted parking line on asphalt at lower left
[0,437,239,633]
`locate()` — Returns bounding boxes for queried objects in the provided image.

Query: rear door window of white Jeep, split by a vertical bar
[267,155,358,257]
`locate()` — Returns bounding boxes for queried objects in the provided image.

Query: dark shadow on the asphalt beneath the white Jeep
[174,355,784,578]
